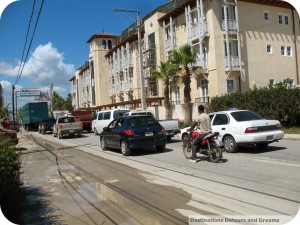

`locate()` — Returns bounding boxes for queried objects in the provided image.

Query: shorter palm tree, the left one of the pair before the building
[151,60,176,119]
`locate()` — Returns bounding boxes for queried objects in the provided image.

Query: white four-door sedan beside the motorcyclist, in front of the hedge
[181,110,284,153]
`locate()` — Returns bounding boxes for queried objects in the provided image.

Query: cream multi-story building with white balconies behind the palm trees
[70,0,300,118]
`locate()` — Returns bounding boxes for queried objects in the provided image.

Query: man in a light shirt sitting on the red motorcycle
[187,105,212,162]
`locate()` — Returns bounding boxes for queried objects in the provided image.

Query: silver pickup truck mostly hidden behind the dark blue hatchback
[124,110,180,142]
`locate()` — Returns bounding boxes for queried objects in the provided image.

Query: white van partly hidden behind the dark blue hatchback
[92,109,130,135]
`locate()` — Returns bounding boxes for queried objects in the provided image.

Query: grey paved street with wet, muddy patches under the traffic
[20,133,300,224]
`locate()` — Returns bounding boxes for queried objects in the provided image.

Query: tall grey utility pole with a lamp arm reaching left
[114,9,147,110]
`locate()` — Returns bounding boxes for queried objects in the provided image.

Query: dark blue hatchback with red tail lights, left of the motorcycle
[100,116,167,156]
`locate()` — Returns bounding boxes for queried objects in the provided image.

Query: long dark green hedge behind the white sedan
[207,83,300,128]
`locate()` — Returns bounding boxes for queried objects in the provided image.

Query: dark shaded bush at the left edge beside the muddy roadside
[0,133,21,222]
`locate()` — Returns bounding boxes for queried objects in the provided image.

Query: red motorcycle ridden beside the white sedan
[183,131,223,163]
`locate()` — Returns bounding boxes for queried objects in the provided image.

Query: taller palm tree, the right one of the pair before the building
[171,44,202,124]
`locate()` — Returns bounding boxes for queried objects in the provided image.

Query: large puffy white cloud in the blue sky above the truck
[0,42,75,97]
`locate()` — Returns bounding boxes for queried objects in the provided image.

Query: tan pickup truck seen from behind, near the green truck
[53,116,82,139]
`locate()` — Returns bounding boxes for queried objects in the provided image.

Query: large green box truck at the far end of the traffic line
[21,102,49,131]
